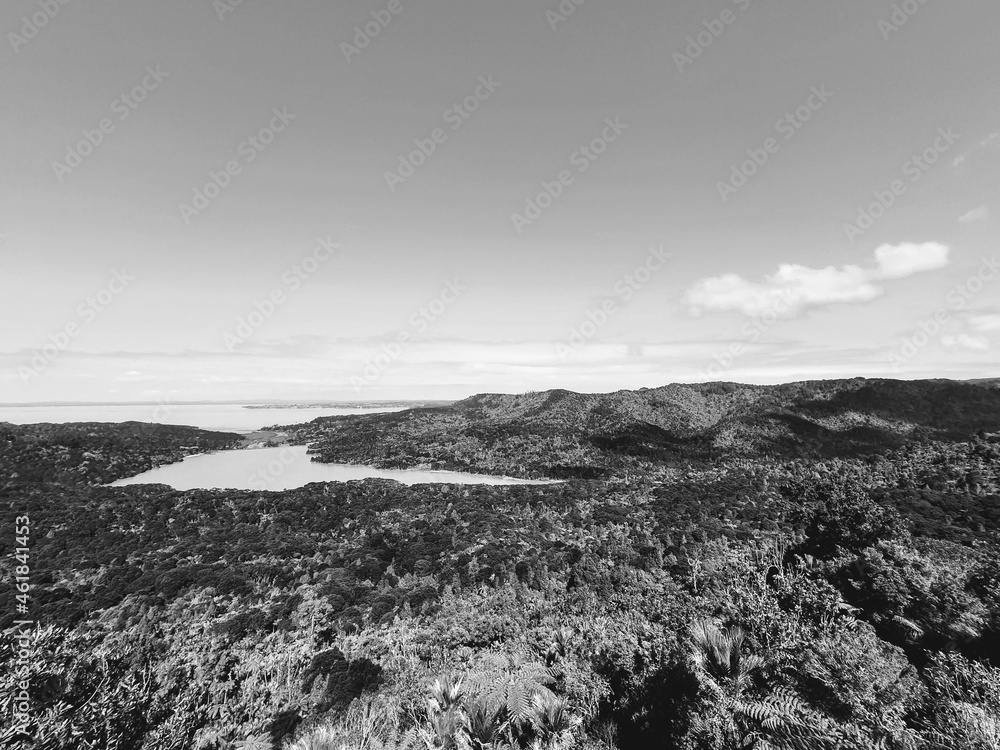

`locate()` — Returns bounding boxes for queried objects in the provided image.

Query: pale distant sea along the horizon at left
[0,403,403,432]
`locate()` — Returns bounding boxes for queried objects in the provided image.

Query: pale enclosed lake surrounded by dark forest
[110,445,553,490]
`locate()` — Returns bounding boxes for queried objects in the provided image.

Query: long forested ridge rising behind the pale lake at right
[285,378,1000,477]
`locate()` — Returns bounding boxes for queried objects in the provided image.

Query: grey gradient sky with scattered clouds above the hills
[0,0,1000,403]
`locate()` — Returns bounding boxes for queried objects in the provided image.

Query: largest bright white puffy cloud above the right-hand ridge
[683,242,949,316]
